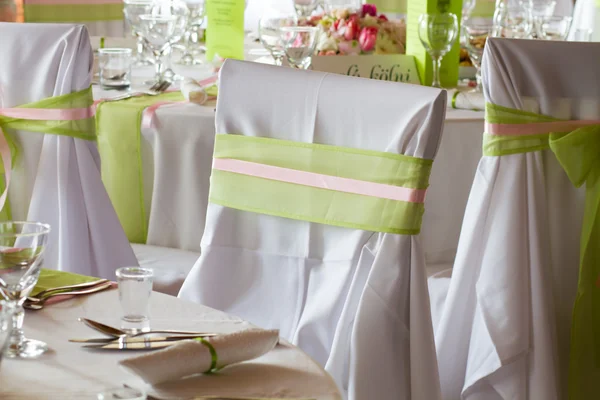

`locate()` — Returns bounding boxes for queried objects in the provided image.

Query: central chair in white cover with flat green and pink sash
[179,60,446,400]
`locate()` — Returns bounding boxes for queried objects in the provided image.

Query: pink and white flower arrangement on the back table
[301,4,406,56]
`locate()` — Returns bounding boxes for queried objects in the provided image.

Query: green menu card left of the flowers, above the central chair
[206,0,246,60]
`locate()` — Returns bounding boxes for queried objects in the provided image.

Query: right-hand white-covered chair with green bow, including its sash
[435,38,600,400]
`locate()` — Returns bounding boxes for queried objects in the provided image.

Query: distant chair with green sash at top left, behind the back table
[23,0,125,37]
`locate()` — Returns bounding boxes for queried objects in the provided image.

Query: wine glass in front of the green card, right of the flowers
[418,13,458,88]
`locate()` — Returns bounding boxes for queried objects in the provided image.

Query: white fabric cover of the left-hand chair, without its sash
[0,23,137,279]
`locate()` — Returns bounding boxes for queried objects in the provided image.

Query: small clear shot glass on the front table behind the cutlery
[117,267,154,333]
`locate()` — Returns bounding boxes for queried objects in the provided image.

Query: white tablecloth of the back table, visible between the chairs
[94,66,483,268]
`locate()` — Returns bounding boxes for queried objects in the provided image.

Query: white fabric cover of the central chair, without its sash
[179,61,446,400]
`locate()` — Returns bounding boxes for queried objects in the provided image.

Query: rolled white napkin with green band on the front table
[120,329,279,385]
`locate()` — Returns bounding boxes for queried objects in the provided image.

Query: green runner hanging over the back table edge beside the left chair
[96,92,184,243]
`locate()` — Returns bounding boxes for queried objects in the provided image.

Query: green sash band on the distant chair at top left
[23,4,123,22]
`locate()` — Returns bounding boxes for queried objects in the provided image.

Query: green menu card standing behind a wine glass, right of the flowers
[406,0,462,88]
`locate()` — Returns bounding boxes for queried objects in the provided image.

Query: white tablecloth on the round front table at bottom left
[0,290,341,400]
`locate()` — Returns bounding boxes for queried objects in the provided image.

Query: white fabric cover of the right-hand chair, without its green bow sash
[435,38,588,400]
